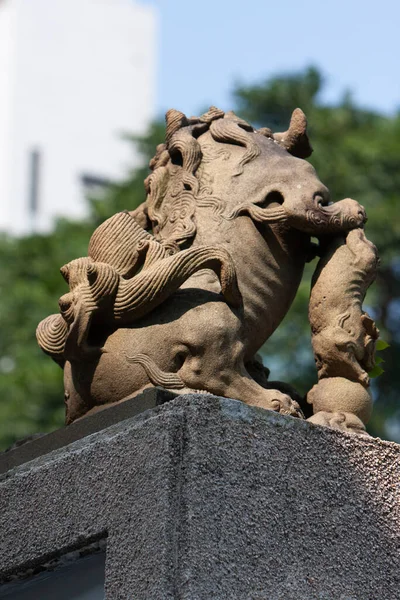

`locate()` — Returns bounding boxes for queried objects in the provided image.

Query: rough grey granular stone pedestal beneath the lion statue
[0,395,400,600]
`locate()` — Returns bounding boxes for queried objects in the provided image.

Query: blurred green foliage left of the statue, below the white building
[0,122,164,449]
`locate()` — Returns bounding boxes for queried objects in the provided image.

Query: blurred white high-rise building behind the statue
[0,0,156,234]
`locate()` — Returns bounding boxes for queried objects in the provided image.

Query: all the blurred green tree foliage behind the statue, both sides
[0,68,400,447]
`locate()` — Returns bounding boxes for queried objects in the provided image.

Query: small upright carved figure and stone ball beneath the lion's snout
[308,229,379,431]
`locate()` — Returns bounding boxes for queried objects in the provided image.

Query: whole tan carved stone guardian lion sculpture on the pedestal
[37,107,377,429]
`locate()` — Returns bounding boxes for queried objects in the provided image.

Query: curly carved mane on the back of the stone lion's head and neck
[133,106,273,246]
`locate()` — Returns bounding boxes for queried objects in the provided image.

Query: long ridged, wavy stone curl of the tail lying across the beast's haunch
[36,240,241,362]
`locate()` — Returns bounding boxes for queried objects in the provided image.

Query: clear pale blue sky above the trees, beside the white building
[146,0,400,119]
